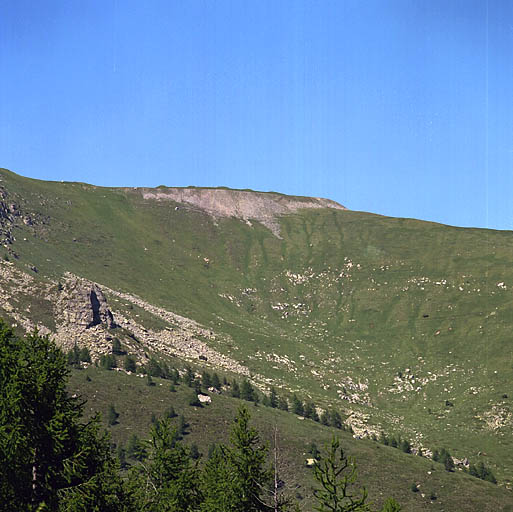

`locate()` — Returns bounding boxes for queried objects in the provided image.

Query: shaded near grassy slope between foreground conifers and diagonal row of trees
[69,367,513,512]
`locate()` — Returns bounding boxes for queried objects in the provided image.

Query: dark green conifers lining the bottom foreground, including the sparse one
[0,321,400,512]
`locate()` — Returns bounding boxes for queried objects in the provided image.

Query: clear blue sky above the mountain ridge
[0,0,513,229]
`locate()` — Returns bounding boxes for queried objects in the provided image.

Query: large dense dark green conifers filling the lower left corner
[0,321,130,512]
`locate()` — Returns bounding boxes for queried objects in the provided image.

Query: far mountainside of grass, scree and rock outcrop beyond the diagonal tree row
[0,166,513,485]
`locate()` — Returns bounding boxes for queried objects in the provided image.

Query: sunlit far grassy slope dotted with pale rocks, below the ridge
[2,171,513,488]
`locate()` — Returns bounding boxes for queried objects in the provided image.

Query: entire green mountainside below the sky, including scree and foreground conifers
[0,169,513,512]
